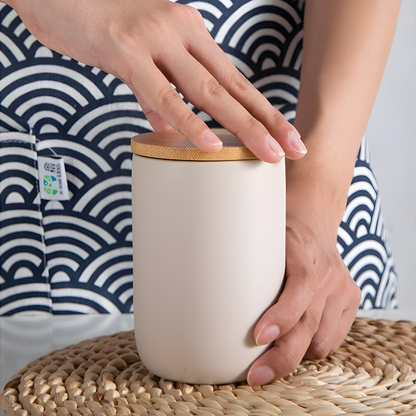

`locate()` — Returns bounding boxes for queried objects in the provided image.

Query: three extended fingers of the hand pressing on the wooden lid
[123,5,306,163]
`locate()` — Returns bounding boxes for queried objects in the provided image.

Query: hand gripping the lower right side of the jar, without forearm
[248,216,361,385]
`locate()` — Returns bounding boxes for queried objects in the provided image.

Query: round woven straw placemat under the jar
[0,318,416,416]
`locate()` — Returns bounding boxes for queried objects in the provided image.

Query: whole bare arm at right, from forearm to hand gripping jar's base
[244,0,400,384]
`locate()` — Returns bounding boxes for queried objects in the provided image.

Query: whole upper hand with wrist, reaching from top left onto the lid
[8,0,306,163]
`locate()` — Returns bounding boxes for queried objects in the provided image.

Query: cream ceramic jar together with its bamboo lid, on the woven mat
[132,130,285,384]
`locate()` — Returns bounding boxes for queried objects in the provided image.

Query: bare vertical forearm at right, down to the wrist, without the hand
[287,0,400,229]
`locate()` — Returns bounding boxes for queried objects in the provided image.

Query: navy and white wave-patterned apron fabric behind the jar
[0,0,397,315]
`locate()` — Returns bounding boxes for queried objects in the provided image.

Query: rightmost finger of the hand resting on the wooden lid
[189,37,307,159]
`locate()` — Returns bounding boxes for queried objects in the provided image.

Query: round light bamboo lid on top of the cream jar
[131,129,257,162]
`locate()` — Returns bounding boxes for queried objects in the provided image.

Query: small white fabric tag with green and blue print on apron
[38,156,69,201]
